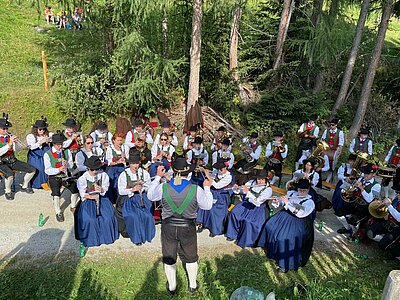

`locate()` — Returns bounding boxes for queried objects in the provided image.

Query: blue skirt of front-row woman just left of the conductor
[122,193,156,244]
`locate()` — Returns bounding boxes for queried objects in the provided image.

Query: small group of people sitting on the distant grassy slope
[44,6,83,29]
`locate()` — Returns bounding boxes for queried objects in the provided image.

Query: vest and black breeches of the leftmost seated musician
[0,136,36,178]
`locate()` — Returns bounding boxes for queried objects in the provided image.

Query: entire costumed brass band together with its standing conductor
[0,114,400,294]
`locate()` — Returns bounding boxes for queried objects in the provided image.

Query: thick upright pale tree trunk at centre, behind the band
[186,0,203,113]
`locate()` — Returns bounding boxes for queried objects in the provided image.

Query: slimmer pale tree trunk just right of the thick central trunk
[229,0,242,81]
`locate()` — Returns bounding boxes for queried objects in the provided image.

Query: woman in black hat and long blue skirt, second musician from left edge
[26,117,53,189]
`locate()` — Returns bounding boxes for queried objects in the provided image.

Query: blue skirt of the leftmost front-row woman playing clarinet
[77,196,119,247]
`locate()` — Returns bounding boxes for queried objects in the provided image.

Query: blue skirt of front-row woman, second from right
[226,200,268,248]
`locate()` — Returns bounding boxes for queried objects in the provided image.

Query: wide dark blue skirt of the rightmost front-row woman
[258,210,314,270]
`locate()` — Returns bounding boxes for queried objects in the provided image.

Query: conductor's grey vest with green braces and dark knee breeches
[161,183,198,265]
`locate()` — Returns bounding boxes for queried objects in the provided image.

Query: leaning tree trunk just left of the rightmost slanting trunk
[332,0,370,115]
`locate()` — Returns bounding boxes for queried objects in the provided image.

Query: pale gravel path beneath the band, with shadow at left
[0,177,347,261]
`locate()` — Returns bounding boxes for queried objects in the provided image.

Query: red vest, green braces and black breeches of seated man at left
[45,149,79,197]
